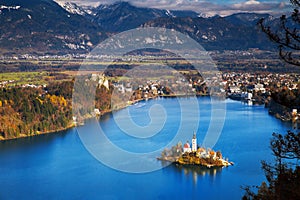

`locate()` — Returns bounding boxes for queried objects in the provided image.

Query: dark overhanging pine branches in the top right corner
[258,0,300,66]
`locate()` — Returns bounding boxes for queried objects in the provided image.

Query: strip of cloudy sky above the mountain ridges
[56,0,292,16]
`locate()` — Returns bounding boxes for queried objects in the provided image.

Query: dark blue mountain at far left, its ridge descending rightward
[0,0,106,53]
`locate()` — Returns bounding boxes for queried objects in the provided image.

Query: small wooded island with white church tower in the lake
[157,133,233,168]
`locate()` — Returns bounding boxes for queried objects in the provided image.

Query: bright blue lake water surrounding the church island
[0,97,291,199]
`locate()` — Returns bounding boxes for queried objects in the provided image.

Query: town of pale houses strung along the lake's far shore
[0,69,300,124]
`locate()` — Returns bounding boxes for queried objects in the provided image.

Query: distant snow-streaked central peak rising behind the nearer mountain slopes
[61,2,199,32]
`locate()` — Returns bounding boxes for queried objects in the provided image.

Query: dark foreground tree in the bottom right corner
[243,131,300,200]
